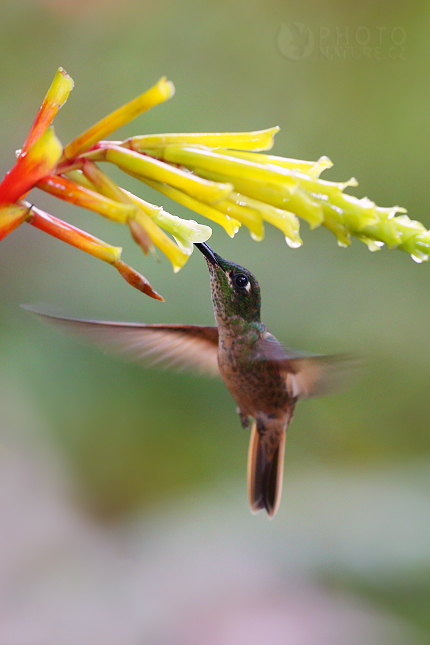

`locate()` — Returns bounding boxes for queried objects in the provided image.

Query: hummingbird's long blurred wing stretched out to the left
[24,307,219,376]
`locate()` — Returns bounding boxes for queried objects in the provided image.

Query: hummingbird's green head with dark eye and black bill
[195,242,261,323]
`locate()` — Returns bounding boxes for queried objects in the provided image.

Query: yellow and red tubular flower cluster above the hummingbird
[0,68,430,300]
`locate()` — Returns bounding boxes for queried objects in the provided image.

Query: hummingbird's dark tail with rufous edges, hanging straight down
[248,421,286,517]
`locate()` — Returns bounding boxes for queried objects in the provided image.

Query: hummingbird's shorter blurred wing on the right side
[254,333,362,399]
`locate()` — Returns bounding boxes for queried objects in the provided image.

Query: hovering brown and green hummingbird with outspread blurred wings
[25,243,351,518]
